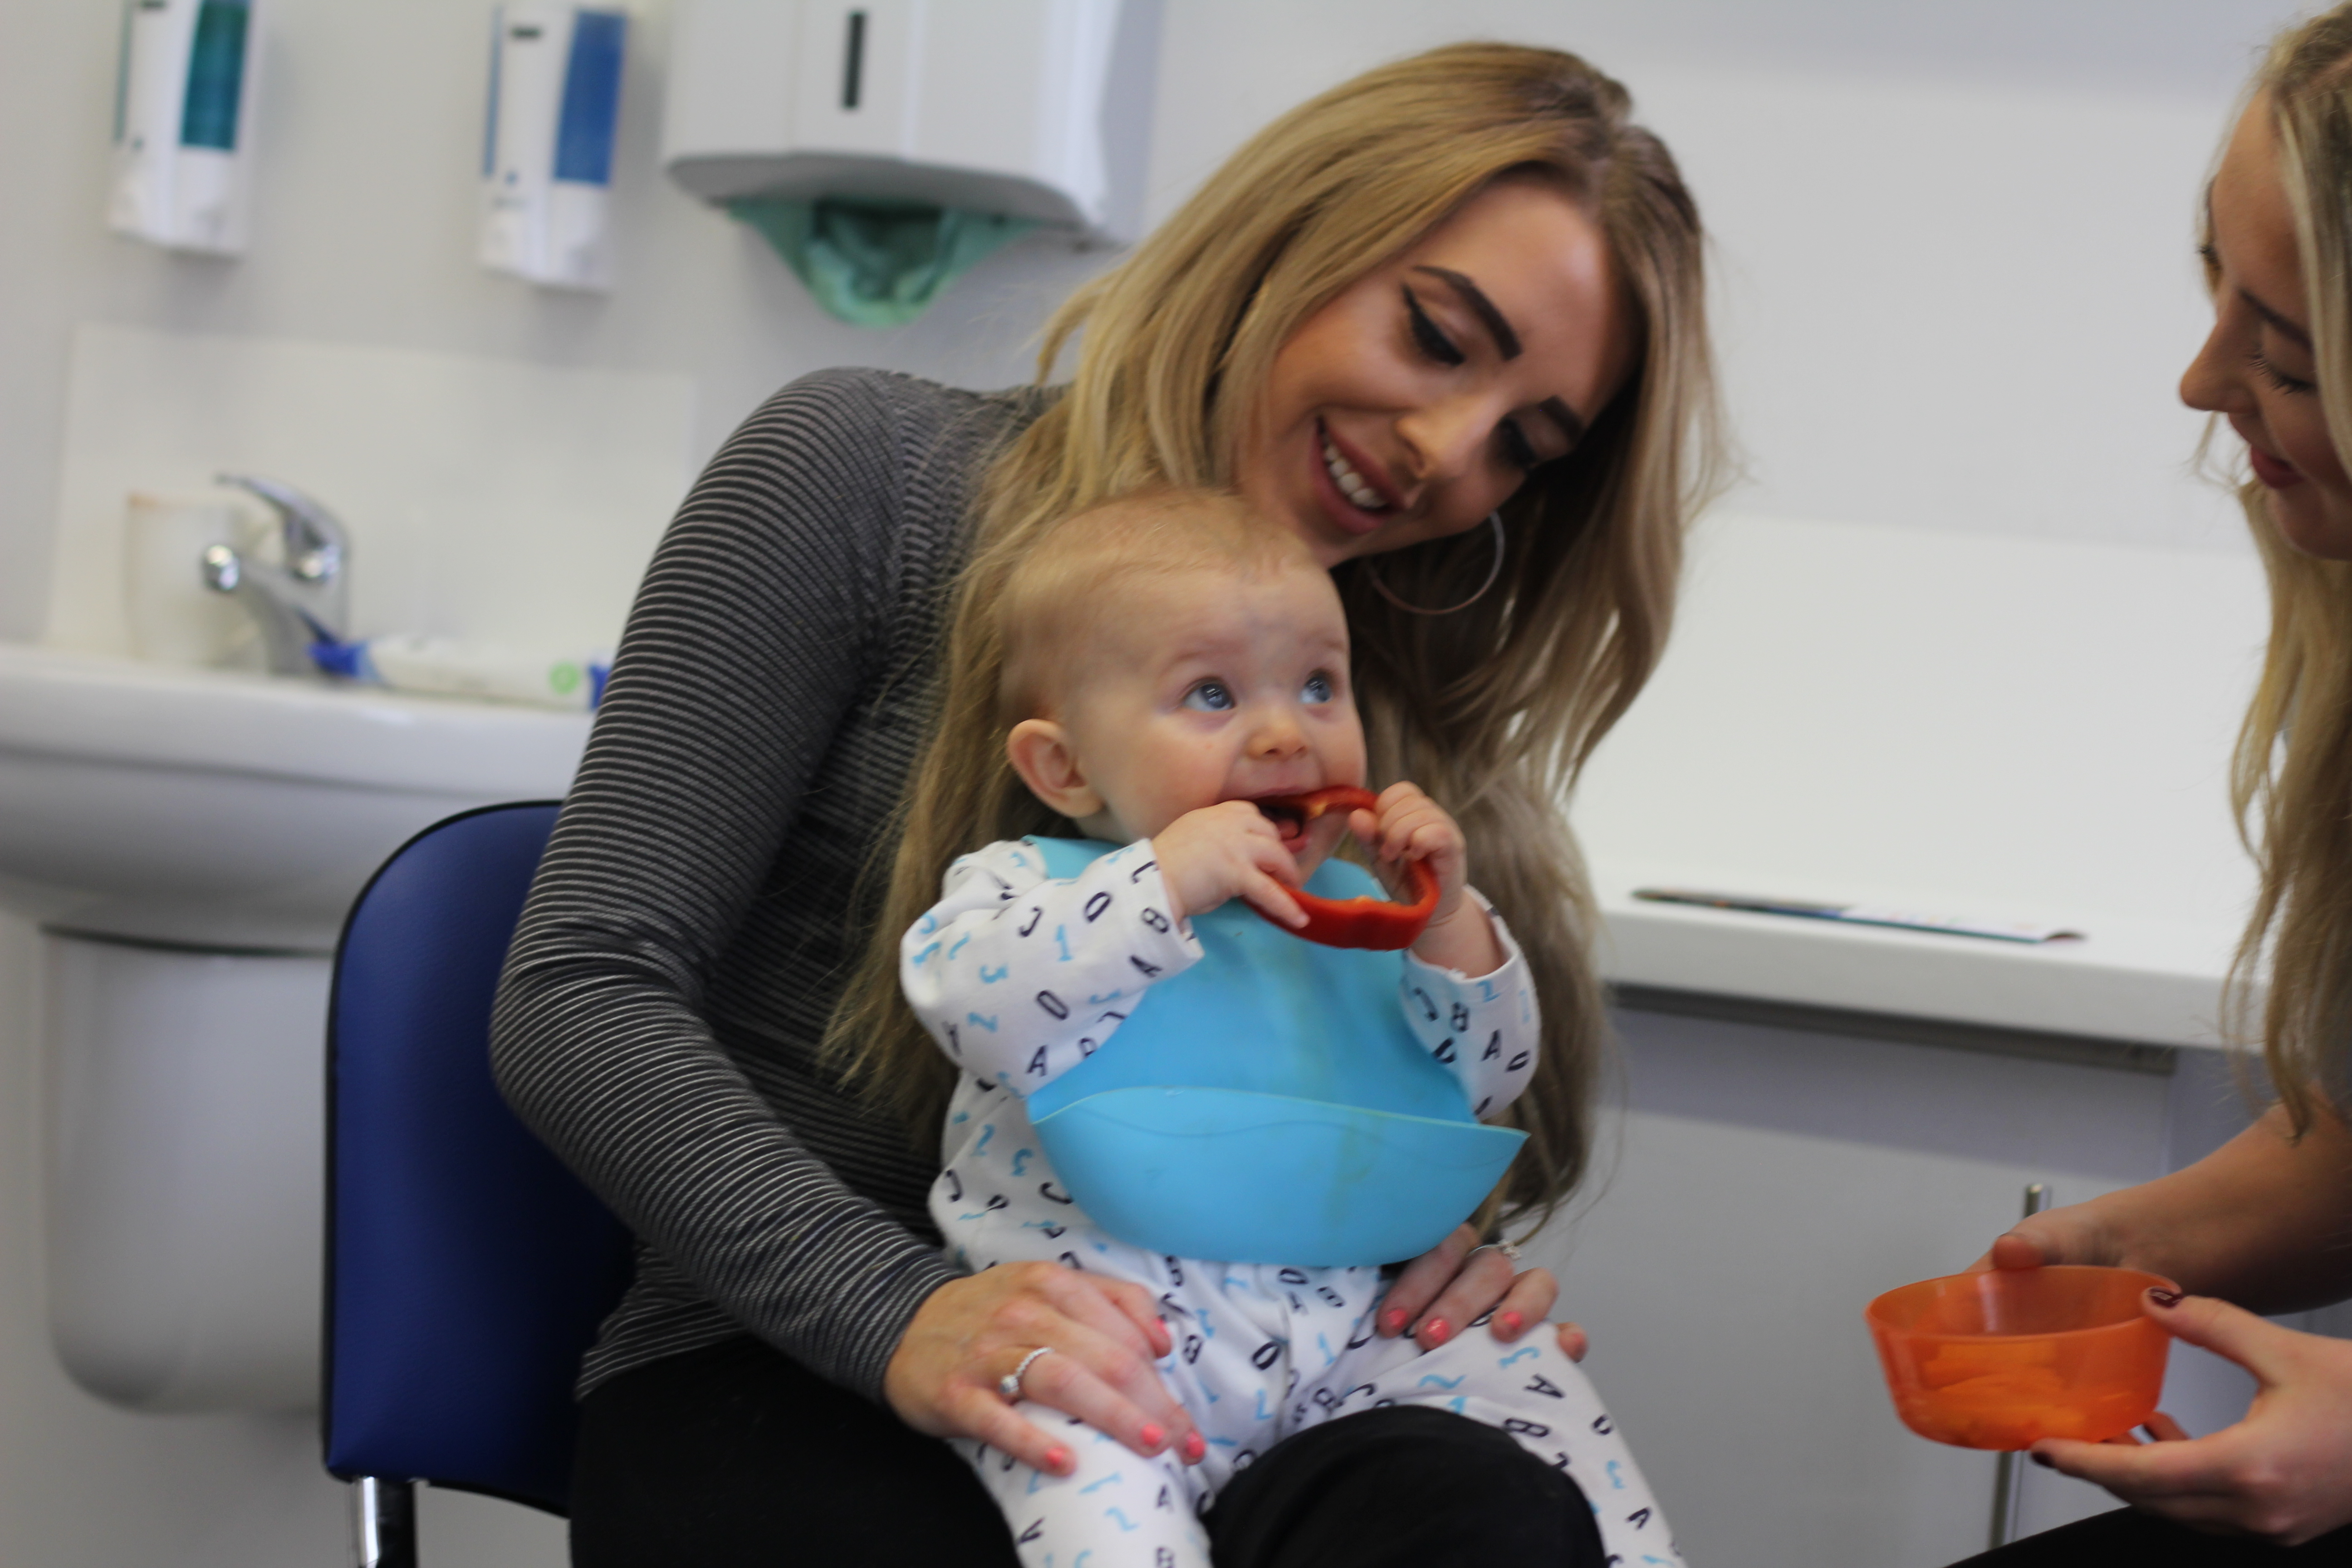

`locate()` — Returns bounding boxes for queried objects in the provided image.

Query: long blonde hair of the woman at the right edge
[2227,5,2352,1136]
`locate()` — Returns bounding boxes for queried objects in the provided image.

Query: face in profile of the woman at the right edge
[2180,99,2352,559]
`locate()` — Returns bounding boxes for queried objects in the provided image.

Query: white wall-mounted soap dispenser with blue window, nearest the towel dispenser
[482,5,628,289]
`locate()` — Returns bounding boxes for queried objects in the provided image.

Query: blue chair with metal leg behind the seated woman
[320,802,628,1568]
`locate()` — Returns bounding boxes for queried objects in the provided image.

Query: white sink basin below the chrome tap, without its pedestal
[0,644,588,952]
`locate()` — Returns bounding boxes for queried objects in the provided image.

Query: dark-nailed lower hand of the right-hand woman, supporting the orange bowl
[2032,1291,2352,1547]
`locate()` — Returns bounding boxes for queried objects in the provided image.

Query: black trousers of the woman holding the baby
[572,1338,1604,1568]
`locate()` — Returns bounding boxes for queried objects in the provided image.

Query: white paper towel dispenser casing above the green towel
[663,0,1160,245]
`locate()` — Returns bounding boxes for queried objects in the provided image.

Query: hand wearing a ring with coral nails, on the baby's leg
[882,1262,1209,1476]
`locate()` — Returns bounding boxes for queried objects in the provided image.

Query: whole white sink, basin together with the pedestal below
[0,644,588,1411]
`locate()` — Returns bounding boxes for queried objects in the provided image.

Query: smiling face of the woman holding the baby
[1237,179,1635,567]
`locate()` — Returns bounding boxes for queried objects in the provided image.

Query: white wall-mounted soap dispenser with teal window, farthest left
[106,0,261,256]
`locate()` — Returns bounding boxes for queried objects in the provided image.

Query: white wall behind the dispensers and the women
[0,0,2296,1568]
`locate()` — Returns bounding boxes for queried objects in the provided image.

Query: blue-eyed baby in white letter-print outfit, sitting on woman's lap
[901,491,1682,1568]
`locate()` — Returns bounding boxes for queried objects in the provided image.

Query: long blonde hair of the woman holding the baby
[828,44,1720,1218]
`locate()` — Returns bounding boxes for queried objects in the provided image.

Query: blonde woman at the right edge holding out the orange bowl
[1976,5,2352,1568]
